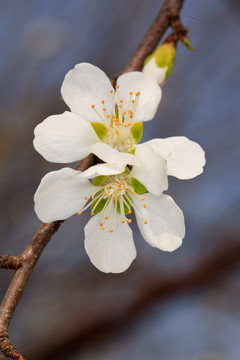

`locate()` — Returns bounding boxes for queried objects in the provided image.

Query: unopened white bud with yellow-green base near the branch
[142,43,176,85]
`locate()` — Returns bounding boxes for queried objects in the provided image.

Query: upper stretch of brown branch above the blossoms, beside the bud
[123,0,184,73]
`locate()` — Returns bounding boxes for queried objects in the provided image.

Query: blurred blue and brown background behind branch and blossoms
[0,0,240,360]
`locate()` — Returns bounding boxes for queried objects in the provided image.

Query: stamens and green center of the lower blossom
[78,173,148,232]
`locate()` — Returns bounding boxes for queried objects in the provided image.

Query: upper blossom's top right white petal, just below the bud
[117,71,162,122]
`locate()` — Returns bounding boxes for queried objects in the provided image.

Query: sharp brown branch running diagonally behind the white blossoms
[0,0,184,360]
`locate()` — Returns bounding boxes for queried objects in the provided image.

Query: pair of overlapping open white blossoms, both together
[34,63,205,273]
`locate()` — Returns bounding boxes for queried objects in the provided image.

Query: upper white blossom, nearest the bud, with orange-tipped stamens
[34,63,161,165]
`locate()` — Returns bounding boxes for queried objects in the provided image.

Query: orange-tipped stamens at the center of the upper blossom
[92,85,142,152]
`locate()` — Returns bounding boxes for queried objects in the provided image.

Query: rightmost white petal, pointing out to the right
[148,136,206,179]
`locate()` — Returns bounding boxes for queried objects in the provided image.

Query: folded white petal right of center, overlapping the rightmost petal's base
[130,143,168,195]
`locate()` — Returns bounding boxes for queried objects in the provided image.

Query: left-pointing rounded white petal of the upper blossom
[33,111,100,163]
